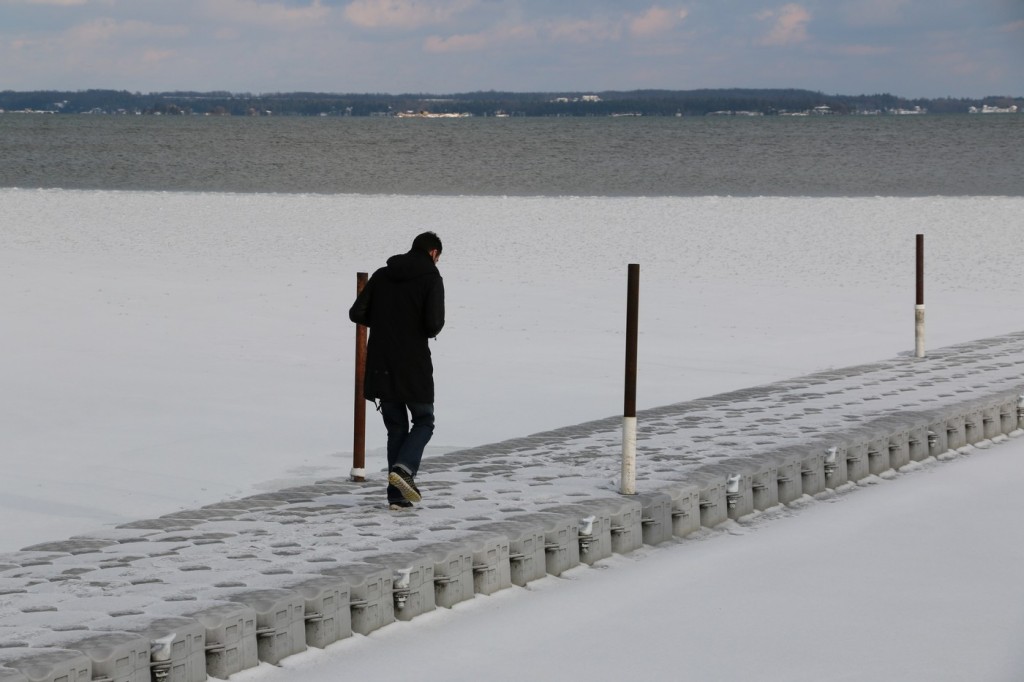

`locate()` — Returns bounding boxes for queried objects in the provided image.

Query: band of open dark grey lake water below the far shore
[0,114,1024,197]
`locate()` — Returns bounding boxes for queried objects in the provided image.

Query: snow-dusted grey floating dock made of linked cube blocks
[0,333,1024,682]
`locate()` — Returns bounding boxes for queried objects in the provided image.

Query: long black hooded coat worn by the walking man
[348,249,444,402]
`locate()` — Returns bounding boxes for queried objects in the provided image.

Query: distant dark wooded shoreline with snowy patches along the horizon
[0,88,1024,117]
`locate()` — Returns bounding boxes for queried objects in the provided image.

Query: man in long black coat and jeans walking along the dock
[348,232,444,510]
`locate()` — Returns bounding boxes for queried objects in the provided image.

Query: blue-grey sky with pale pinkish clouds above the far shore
[0,0,1024,97]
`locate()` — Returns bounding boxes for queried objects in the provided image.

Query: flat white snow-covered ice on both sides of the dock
[0,189,1024,682]
